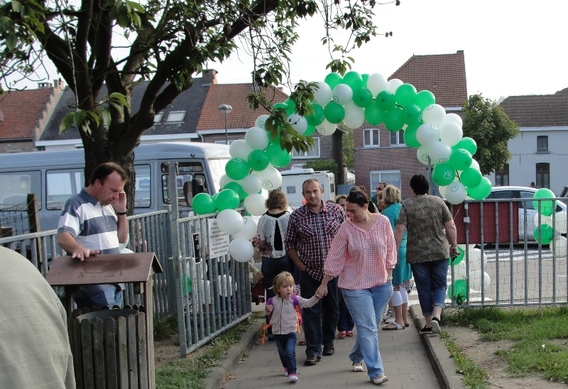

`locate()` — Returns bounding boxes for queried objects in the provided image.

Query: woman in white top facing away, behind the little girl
[254,189,294,340]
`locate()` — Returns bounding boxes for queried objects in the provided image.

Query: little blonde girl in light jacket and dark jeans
[266,271,319,382]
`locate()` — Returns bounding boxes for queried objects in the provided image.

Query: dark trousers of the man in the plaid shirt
[300,272,339,356]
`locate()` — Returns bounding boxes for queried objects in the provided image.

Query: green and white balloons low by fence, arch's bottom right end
[448,246,491,305]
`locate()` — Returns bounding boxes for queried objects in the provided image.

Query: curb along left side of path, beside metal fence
[205,318,264,389]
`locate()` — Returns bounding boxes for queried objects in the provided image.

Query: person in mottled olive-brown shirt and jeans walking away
[395,174,459,333]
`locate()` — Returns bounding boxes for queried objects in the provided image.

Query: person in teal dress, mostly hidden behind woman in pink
[379,185,412,330]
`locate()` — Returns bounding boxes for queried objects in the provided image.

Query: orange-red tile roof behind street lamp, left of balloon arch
[197,83,288,130]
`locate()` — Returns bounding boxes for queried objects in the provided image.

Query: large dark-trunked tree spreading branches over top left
[0,0,398,212]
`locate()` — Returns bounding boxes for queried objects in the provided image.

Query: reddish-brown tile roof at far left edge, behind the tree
[0,88,53,140]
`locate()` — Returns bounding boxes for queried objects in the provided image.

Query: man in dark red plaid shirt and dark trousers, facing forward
[285,178,345,366]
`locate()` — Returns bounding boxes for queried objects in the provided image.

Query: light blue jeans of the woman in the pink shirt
[342,282,392,379]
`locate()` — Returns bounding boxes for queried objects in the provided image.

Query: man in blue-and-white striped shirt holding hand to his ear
[57,162,128,308]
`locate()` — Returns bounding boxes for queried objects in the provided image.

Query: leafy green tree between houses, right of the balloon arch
[462,95,519,174]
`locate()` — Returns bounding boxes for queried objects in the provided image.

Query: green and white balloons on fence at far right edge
[532,188,567,258]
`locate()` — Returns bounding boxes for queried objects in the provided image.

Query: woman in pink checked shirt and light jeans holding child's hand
[316,191,397,385]
